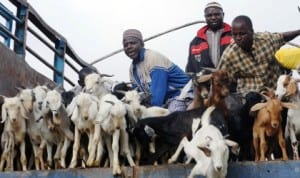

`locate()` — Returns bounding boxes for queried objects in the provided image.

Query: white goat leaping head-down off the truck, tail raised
[169,106,238,178]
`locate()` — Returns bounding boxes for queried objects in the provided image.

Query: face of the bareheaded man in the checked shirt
[232,22,253,50]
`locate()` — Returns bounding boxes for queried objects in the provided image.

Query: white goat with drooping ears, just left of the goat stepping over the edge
[67,92,100,168]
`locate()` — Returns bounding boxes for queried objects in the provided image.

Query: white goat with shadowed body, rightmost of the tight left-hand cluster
[38,89,74,168]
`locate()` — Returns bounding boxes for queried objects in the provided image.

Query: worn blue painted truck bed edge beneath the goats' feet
[0,161,300,178]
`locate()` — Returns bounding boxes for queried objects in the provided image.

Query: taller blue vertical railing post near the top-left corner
[14,4,28,59]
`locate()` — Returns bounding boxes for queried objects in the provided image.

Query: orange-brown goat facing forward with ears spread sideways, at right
[251,98,297,161]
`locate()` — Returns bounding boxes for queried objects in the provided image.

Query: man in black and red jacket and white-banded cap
[185,2,232,73]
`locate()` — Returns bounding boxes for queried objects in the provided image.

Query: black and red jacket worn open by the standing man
[185,23,232,73]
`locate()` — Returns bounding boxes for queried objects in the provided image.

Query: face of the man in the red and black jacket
[204,7,224,31]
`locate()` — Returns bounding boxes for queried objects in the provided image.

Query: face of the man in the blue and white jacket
[123,37,143,60]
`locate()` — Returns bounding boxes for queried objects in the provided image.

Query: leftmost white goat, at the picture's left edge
[0,96,27,171]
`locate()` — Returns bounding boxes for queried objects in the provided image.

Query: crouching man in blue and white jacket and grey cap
[123,29,192,112]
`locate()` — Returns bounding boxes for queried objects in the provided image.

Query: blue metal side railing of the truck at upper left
[0,0,95,86]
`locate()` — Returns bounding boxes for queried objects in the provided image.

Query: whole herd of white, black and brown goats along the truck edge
[0,70,300,178]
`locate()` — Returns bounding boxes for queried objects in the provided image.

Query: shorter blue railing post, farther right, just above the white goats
[53,40,66,86]
